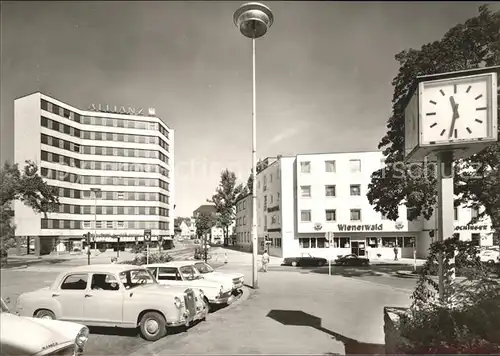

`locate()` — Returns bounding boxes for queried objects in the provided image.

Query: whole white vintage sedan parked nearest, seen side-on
[17,264,208,341]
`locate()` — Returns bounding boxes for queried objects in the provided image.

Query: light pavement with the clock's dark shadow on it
[135,264,411,356]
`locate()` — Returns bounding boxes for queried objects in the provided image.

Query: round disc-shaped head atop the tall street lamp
[233,2,274,38]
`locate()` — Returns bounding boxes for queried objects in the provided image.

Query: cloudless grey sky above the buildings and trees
[0,1,494,216]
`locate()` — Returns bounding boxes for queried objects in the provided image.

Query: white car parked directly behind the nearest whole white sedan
[146,261,233,310]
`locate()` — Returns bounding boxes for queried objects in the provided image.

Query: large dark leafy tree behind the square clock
[367,5,500,245]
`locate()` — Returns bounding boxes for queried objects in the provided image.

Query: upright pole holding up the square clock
[436,151,455,301]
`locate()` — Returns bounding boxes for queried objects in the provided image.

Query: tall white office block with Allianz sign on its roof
[14,93,174,254]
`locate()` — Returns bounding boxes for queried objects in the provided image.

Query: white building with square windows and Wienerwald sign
[237,152,493,259]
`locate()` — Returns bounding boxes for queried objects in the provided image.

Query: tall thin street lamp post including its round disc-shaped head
[233,2,274,288]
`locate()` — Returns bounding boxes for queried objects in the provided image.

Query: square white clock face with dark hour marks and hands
[420,76,491,144]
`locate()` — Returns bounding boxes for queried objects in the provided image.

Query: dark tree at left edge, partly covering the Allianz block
[0,161,59,251]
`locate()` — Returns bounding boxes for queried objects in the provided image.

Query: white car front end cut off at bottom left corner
[0,299,89,356]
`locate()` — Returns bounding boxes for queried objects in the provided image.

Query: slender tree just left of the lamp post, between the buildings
[207,169,243,245]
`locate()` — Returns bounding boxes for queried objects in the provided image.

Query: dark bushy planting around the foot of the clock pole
[396,238,500,354]
